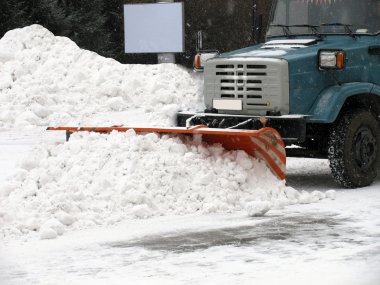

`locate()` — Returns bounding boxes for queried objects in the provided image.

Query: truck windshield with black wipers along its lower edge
[267,0,380,36]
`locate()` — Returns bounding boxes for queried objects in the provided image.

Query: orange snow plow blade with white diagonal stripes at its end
[47,126,286,180]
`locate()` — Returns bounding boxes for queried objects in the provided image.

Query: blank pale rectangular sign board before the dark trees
[124,3,184,53]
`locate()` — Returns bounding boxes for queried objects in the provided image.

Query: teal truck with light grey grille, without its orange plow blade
[177,0,380,188]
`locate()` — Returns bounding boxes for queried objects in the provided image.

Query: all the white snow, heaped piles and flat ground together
[0,25,380,285]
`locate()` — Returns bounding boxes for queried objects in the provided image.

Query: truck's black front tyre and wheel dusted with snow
[328,110,380,188]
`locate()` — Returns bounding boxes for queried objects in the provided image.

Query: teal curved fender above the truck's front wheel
[307,82,380,123]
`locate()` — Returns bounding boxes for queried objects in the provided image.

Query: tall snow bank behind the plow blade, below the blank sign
[0,25,201,127]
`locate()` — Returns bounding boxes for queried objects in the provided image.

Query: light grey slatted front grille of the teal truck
[205,59,289,115]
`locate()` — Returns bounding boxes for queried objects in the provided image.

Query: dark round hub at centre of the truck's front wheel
[353,127,377,170]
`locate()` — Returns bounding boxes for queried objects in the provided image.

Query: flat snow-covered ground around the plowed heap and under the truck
[0,130,380,285]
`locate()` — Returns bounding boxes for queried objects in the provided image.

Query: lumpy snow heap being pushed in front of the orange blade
[0,130,332,238]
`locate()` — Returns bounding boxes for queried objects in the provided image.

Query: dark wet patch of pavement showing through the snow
[109,213,348,253]
